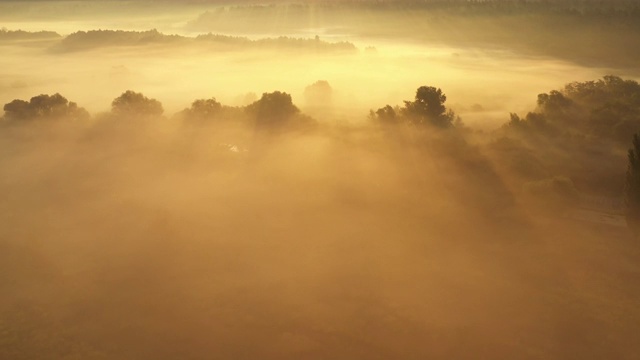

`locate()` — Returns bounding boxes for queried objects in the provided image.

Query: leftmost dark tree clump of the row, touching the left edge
[3,94,89,121]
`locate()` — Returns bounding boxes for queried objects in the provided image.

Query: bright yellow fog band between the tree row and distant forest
[0,34,606,127]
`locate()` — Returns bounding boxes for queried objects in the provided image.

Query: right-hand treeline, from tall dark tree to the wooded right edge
[369,75,640,204]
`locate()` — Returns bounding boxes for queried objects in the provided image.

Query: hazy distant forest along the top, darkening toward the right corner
[185,0,640,68]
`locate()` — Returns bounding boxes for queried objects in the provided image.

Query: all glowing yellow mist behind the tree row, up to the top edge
[0,1,638,127]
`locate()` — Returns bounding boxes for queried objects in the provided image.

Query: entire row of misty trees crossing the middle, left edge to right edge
[0,76,640,203]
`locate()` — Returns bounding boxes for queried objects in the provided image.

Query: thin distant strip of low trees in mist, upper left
[0,29,357,52]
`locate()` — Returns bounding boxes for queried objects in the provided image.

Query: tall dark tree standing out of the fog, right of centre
[403,86,455,127]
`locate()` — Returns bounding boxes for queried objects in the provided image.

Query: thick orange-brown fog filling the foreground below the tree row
[1,109,638,359]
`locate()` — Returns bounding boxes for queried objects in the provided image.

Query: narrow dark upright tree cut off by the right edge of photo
[624,134,640,233]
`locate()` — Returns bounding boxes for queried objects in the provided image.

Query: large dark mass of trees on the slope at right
[487,76,640,197]
